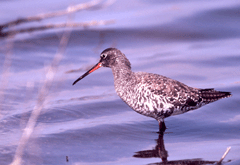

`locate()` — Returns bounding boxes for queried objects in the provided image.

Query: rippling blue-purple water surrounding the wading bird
[0,0,240,165]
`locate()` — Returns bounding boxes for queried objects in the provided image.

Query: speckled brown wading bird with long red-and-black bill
[72,48,231,135]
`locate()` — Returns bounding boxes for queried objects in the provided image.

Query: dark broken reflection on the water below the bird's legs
[133,134,216,165]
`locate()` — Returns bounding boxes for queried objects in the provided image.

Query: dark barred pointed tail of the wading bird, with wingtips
[199,88,232,103]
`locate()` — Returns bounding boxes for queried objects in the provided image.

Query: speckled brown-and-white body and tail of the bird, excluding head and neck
[117,72,231,120]
